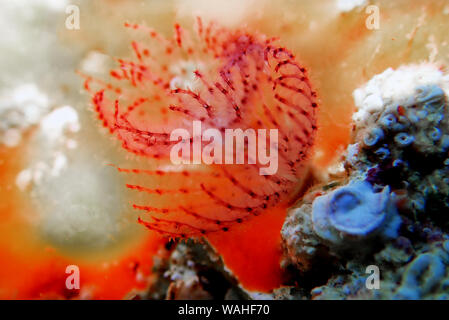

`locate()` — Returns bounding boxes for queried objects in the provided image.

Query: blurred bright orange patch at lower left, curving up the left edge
[0,146,166,299]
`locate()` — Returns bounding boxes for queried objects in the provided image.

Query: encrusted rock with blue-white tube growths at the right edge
[282,64,449,299]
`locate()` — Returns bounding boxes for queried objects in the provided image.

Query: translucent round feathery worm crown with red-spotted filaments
[85,19,317,238]
